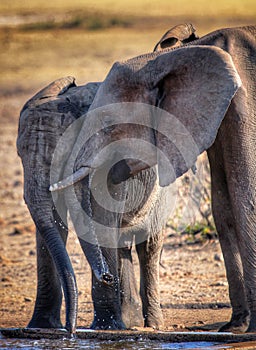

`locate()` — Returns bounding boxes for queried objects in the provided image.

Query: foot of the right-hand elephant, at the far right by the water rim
[219,311,250,333]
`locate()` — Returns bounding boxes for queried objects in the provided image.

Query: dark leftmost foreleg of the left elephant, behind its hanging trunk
[28,205,67,328]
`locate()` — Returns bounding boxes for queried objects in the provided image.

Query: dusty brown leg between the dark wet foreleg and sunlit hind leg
[118,234,144,328]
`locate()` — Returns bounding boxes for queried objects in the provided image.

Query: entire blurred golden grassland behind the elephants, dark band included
[0,0,256,95]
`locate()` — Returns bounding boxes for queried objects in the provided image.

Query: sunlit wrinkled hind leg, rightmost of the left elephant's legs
[136,232,164,328]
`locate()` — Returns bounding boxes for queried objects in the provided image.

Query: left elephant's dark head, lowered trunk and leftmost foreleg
[17,77,99,333]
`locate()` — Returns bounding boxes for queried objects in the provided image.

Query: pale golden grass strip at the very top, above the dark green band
[0,0,256,17]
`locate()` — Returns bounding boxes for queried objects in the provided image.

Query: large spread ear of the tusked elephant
[145,46,241,186]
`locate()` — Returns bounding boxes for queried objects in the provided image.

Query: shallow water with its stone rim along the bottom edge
[0,328,256,350]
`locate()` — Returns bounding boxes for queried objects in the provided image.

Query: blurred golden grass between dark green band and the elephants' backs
[0,29,158,93]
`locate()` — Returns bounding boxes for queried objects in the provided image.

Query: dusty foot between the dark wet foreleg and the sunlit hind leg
[122,302,144,328]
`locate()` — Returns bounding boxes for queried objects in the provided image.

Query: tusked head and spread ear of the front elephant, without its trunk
[51,46,241,190]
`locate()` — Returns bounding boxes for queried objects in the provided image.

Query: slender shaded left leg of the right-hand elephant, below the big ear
[208,147,249,332]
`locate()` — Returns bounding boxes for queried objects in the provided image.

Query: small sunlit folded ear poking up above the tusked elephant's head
[154,23,198,51]
